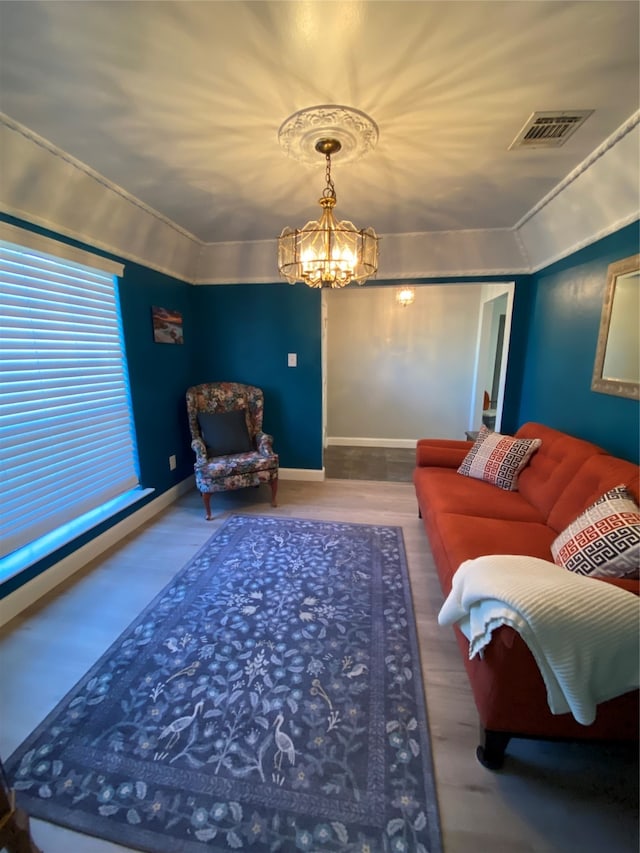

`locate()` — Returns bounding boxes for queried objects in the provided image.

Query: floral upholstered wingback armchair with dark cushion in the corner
[182,382,278,521]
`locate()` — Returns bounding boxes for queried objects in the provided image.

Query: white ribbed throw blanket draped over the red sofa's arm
[438,555,640,726]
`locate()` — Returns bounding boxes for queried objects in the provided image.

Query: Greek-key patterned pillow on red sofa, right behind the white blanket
[551,485,640,578]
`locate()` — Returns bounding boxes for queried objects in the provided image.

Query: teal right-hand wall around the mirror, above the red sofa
[518,222,640,462]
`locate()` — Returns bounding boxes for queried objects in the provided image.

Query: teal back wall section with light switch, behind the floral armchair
[193,283,322,469]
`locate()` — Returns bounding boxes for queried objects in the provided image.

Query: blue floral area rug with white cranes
[6,515,441,853]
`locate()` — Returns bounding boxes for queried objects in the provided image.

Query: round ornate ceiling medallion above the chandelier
[278,104,378,165]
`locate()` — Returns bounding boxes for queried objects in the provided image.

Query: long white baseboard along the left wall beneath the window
[0,475,195,626]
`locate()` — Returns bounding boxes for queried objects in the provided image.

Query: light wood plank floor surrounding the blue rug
[0,479,638,853]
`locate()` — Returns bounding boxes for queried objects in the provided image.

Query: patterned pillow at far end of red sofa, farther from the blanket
[458,424,542,492]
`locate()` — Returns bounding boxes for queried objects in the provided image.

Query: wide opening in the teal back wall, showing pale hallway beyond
[321,282,515,467]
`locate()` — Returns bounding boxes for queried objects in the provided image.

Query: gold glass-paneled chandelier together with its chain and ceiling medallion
[278,106,378,287]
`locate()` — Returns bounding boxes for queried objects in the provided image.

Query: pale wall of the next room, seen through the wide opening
[325,284,482,443]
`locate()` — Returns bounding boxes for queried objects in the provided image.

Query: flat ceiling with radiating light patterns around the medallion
[0,0,640,242]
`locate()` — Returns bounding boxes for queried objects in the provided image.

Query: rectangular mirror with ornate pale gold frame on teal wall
[591,254,640,400]
